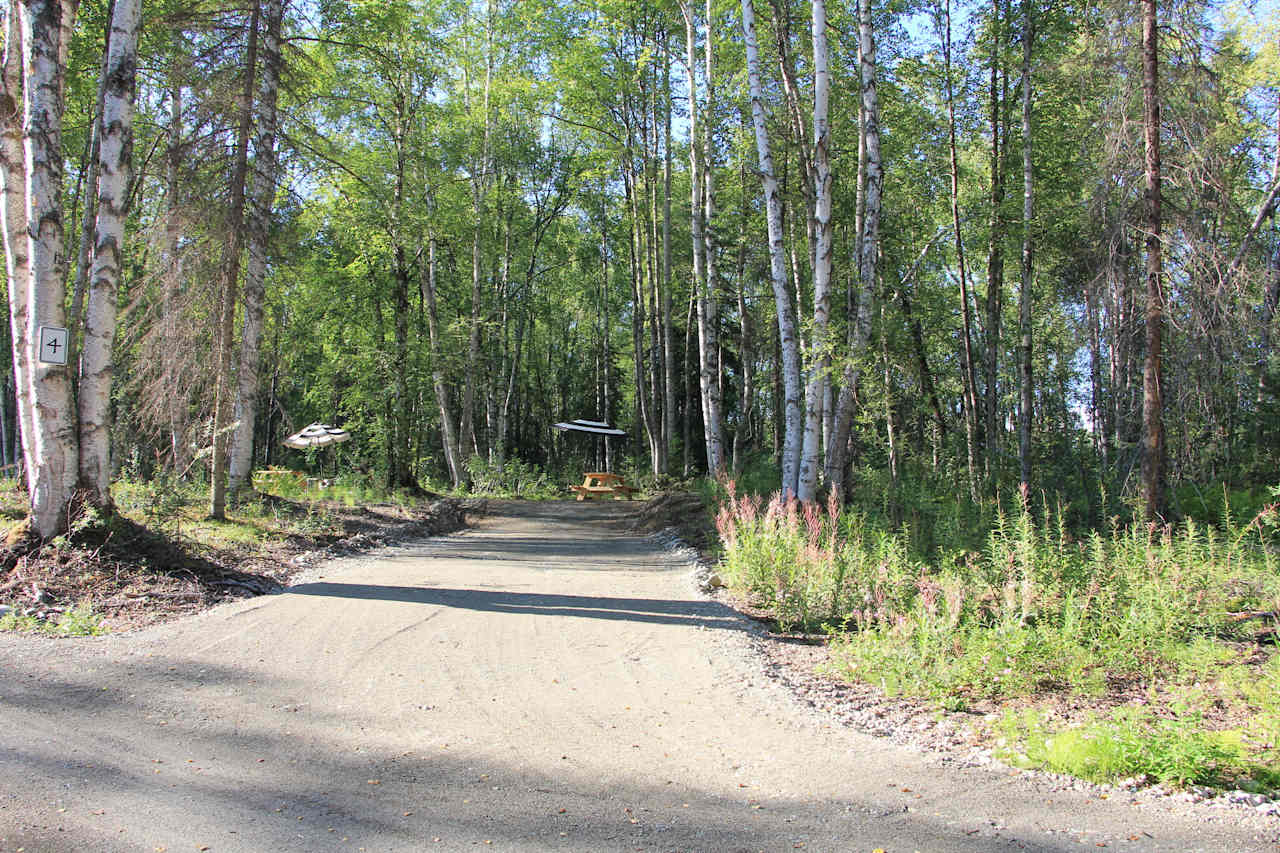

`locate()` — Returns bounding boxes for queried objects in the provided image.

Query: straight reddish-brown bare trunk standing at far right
[1142,0,1165,520]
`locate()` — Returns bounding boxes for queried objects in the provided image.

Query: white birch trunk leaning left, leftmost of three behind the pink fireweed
[742,0,801,498]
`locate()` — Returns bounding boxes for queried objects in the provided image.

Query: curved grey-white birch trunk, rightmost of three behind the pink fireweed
[815,0,884,499]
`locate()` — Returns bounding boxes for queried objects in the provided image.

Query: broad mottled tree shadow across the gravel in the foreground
[0,657,1079,853]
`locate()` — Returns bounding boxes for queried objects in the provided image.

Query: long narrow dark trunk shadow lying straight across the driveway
[284,581,748,631]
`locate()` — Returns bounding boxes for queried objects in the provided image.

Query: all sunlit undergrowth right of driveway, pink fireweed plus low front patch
[717,483,1280,786]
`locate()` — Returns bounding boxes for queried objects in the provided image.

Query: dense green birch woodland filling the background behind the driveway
[0,0,1280,535]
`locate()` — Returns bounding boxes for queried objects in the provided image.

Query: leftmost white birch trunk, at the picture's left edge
[0,0,36,494]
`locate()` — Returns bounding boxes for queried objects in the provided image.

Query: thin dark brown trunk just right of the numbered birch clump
[209,0,262,519]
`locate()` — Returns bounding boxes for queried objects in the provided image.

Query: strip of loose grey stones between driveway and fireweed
[649,528,1280,844]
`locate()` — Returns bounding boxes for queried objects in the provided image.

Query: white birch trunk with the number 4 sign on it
[20,0,77,537]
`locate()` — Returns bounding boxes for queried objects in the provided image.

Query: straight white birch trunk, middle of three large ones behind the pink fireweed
[796,0,832,501]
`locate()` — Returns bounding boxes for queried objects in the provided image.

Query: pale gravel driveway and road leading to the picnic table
[0,502,1275,853]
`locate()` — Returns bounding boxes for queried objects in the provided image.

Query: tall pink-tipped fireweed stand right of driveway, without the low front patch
[717,484,1280,702]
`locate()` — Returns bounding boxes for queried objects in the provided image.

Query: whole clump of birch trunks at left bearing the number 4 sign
[0,0,141,537]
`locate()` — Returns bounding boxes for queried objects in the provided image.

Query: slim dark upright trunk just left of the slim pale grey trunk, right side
[984,0,1005,484]
